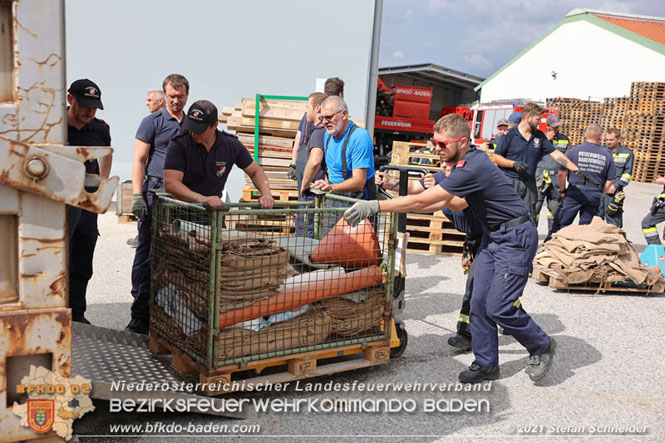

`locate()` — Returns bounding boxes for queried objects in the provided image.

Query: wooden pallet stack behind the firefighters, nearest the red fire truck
[547,97,603,145]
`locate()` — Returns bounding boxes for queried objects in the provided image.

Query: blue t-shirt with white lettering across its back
[561,142,616,186]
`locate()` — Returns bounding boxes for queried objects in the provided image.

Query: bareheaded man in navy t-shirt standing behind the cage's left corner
[125,74,189,334]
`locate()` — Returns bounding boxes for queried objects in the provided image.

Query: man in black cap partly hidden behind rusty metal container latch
[67,79,112,323]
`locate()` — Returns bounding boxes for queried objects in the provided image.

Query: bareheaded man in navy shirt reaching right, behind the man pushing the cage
[493,103,577,220]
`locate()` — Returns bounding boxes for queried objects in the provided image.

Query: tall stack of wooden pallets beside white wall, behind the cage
[219,98,307,234]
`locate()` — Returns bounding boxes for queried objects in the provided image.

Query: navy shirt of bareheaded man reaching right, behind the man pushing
[494,126,554,181]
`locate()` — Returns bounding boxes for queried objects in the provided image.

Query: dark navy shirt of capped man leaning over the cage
[164,130,253,196]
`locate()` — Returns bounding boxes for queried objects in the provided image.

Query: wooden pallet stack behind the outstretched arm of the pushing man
[391,141,465,255]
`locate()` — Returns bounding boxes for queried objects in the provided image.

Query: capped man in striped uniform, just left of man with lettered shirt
[536,114,570,232]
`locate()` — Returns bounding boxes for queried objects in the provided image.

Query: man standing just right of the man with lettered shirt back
[598,128,635,228]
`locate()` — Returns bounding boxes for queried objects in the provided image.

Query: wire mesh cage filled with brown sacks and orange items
[150,195,396,369]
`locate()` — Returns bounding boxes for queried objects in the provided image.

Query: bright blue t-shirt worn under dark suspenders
[323,121,374,183]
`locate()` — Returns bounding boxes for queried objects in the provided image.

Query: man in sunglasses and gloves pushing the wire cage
[344,114,556,383]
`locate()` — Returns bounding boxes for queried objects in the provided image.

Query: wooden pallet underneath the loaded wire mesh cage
[150,330,390,395]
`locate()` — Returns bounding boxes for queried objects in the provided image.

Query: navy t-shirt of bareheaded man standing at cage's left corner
[135,108,184,178]
